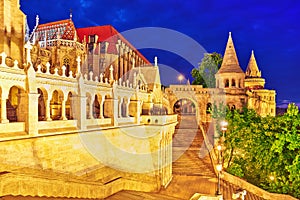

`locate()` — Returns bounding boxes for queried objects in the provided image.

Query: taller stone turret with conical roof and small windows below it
[215,32,245,88]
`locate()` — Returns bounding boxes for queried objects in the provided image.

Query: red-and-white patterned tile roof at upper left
[35,19,76,41]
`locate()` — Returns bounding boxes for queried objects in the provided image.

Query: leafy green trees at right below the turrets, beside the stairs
[212,104,300,198]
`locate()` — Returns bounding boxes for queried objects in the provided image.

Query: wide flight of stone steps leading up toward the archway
[173,116,216,178]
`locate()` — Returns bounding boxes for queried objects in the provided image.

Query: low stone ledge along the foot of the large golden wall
[0,174,157,199]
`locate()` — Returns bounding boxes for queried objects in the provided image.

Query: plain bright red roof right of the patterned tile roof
[76,25,150,64]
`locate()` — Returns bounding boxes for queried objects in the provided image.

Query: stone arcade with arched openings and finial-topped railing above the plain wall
[0,49,161,139]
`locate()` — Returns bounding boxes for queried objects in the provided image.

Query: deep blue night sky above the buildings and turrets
[20,0,300,107]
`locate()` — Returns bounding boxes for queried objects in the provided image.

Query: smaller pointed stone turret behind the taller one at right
[245,51,265,89]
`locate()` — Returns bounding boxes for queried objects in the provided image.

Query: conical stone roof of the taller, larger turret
[218,32,244,73]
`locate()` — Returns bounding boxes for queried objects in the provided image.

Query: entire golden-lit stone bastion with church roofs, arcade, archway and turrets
[0,0,275,198]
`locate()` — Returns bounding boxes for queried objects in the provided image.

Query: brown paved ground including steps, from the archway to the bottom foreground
[0,116,262,200]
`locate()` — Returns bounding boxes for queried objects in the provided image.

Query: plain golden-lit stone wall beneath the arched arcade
[0,120,176,198]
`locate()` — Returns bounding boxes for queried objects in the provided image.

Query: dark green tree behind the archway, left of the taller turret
[191,52,223,88]
